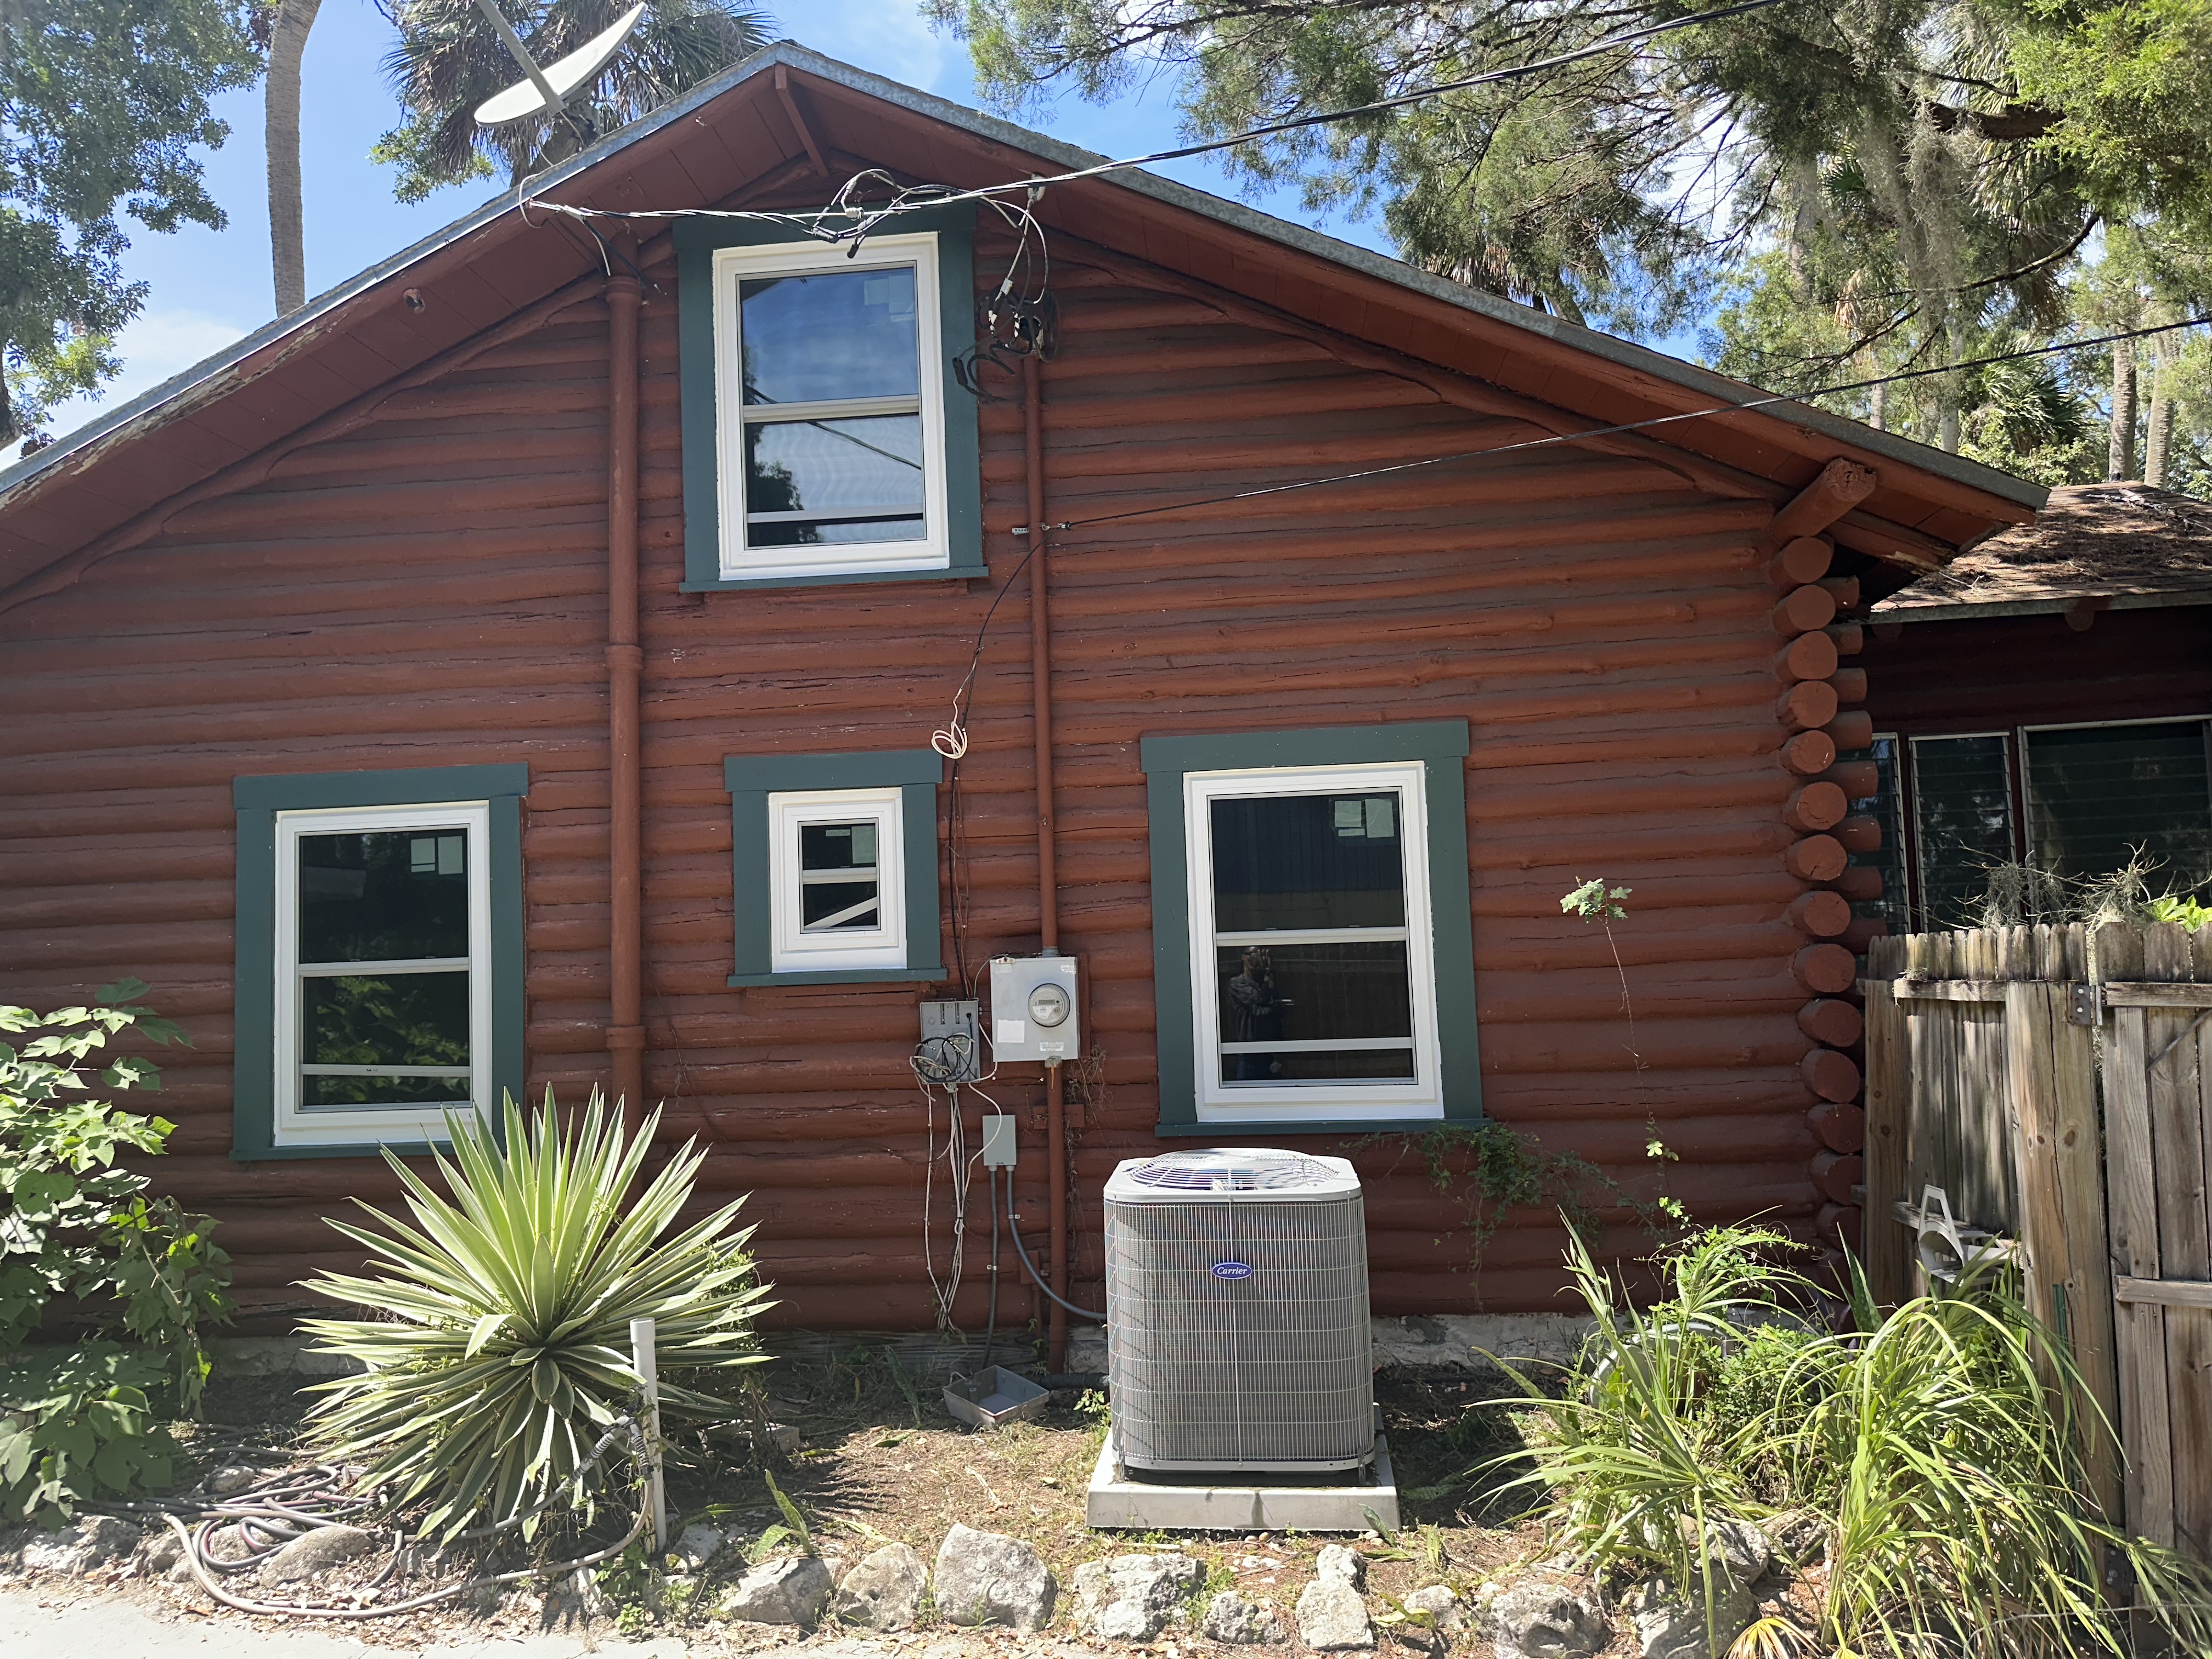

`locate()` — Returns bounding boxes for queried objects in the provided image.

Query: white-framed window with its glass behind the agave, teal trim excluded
[274,801,491,1146]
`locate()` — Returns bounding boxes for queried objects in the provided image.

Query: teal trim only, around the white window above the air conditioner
[1139,721,1482,1137]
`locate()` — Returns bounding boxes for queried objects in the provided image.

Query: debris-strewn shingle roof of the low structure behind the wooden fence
[1871,484,2212,622]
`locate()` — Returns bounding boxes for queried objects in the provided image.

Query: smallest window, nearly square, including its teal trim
[723,750,945,984]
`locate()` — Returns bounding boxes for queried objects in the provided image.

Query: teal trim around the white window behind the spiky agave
[230,763,531,1161]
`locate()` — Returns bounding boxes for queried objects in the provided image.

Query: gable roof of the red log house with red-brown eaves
[0,40,2044,600]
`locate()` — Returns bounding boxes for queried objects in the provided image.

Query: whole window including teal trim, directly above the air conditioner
[1144,721,1482,1135]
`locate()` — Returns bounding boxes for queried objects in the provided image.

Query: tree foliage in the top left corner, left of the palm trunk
[0,0,259,442]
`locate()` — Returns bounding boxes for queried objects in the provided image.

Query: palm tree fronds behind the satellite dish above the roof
[374,0,770,201]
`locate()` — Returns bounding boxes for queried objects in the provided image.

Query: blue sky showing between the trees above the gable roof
[49,0,1557,433]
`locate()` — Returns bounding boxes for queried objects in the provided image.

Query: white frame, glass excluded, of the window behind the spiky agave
[272,801,491,1146]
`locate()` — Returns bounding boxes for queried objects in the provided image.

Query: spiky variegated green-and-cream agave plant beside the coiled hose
[303,1091,768,1539]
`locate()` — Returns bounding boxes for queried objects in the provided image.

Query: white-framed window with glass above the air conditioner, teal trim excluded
[1183,761,1444,1124]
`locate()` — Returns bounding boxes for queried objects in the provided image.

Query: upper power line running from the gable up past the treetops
[535,0,1783,241]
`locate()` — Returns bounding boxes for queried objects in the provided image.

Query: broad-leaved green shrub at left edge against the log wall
[0,980,232,1524]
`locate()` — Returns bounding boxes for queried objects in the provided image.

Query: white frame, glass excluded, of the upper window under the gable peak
[714,230,951,579]
